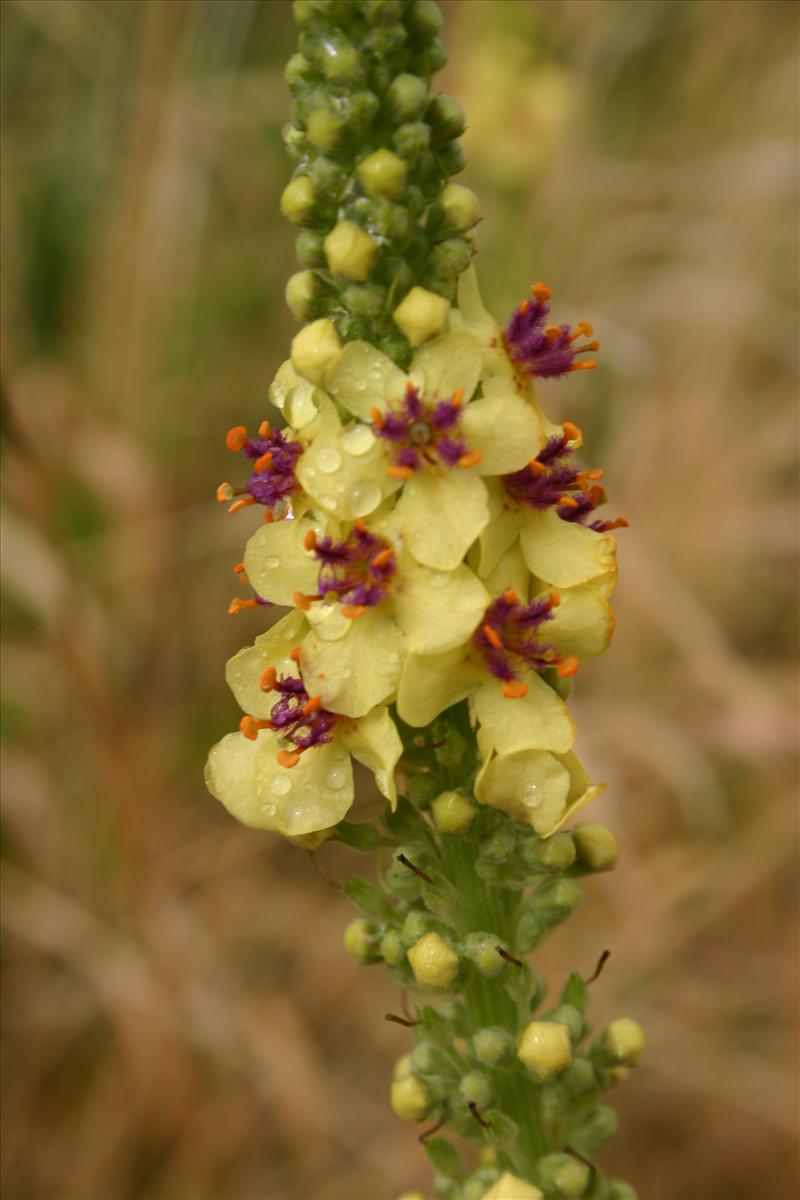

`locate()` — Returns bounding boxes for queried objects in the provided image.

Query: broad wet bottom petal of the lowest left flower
[205,730,353,838]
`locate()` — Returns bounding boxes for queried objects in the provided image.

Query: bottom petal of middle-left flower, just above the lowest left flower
[300,601,402,716]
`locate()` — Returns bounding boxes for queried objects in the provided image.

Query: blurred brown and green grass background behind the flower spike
[0,0,800,1200]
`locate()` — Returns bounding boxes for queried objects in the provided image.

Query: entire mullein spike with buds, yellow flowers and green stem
[206,0,643,1200]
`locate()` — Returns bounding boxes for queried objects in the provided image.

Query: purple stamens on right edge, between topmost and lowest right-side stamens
[503,421,628,533]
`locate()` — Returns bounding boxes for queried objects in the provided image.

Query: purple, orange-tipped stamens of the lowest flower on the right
[473,588,578,700]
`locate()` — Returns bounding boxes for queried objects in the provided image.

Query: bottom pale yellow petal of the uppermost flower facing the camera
[395,467,489,571]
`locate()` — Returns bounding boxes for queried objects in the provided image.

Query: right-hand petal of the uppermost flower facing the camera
[461,390,543,475]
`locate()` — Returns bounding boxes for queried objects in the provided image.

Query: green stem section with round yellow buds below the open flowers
[336,703,644,1200]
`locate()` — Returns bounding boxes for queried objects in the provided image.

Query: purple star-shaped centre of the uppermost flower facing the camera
[372,380,481,479]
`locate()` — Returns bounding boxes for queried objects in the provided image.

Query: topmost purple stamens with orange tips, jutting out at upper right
[504,283,600,378]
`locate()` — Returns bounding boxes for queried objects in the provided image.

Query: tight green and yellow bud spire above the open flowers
[281,0,480,365]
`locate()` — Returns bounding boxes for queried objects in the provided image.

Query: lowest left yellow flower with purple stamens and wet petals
[205,612,402,838]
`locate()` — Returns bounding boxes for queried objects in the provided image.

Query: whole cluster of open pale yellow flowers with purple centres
[206,268,625,840]
